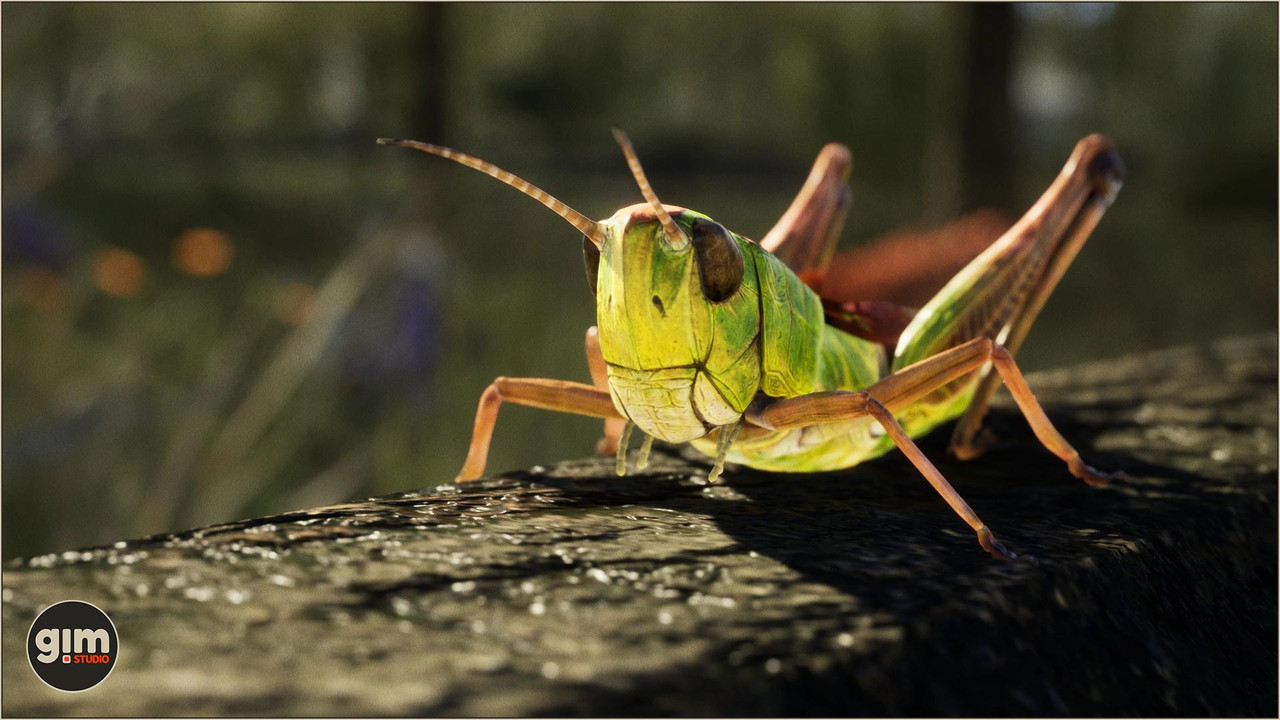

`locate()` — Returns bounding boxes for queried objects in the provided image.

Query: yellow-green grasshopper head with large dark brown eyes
[584,198,759,442]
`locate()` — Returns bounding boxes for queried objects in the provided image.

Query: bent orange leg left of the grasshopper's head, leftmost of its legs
[454,378,622,483]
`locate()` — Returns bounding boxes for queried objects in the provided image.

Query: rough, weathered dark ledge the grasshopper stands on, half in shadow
[3,337,1277,716]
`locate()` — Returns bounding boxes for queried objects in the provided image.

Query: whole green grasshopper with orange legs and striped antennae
[379,129,1124,560]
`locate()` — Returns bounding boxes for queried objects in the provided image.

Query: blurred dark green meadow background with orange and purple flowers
[0,4,1277,557]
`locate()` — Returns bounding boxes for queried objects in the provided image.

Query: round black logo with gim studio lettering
[27,600,119,693]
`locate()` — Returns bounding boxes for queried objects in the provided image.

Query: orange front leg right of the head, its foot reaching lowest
[748,391,1034,562]
